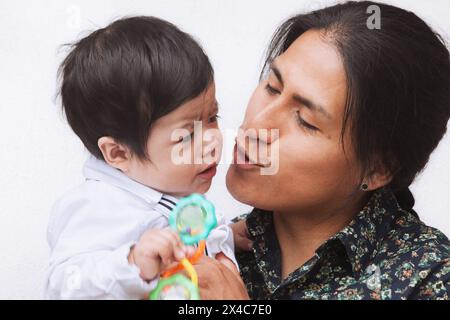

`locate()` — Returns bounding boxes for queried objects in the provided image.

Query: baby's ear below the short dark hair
[97,137,131,172]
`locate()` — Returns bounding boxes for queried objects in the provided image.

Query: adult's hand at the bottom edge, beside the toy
[194,256,250,300]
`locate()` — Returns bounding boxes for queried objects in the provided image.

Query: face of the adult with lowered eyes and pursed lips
[227,31,360,212]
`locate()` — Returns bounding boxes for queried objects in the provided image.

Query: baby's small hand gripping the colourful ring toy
[128,228,195,281]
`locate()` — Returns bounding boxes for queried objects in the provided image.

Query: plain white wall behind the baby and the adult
[0,0,450,299]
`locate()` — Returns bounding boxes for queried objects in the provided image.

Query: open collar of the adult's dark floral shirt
[246,187,408,284]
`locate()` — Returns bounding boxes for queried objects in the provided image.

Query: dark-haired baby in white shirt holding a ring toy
[45,17,237,299]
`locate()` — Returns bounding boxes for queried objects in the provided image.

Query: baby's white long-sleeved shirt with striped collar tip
[45,156,237,299]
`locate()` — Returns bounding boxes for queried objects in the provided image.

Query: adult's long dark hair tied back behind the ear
[261,1,450,209]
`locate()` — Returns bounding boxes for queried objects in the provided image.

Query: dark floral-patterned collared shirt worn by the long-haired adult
[237,188,450,300]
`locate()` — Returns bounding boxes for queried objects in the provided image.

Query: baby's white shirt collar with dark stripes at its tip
[83,155,178,216]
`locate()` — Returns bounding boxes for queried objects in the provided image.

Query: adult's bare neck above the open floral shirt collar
[273,191,368,279]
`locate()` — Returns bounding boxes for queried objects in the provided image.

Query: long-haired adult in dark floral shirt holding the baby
[196,1,450,299]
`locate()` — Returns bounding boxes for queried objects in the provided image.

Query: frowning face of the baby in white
[127,83,222,196]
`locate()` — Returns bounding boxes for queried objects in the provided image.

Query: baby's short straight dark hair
[58,17,214,159]
